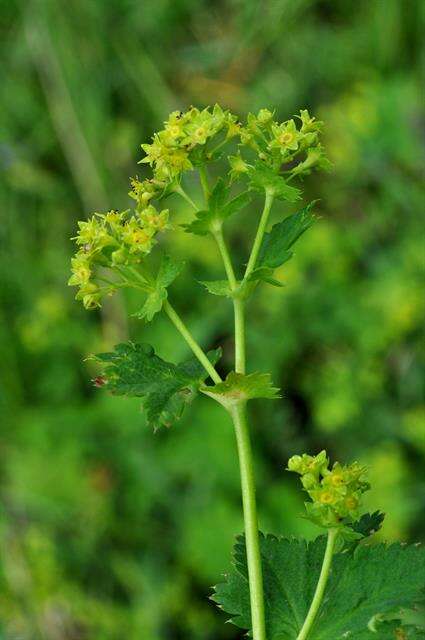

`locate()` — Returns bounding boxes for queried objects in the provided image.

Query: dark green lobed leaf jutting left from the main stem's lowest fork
[93,342,221,428]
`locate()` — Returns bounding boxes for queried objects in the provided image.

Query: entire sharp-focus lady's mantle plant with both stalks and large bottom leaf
[69,105,425,640]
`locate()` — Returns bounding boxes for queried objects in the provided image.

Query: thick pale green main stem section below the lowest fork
[231,403,266,640]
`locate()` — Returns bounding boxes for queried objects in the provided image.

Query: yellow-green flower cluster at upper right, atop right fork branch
[230,109,330,176]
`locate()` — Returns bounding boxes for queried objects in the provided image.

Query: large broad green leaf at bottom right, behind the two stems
[213,535,425,640]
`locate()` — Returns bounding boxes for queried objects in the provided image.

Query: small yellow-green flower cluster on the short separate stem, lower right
[288,451,369,528]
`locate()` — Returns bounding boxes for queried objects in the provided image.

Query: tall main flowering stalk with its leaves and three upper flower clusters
[68,104,332,640]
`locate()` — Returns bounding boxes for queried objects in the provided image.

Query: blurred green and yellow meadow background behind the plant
[0,0,425,640]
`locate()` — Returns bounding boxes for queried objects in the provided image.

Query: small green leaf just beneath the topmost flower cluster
[182,178,251,236]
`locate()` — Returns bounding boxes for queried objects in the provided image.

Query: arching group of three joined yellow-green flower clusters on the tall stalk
[69,105,329,309]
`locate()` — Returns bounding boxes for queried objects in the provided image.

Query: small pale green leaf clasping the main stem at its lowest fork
[201,371,279,408]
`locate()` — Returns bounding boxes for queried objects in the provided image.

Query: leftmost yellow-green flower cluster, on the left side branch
[68,204,168,309]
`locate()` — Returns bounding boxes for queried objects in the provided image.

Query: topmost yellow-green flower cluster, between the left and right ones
[141,104,240,187]
